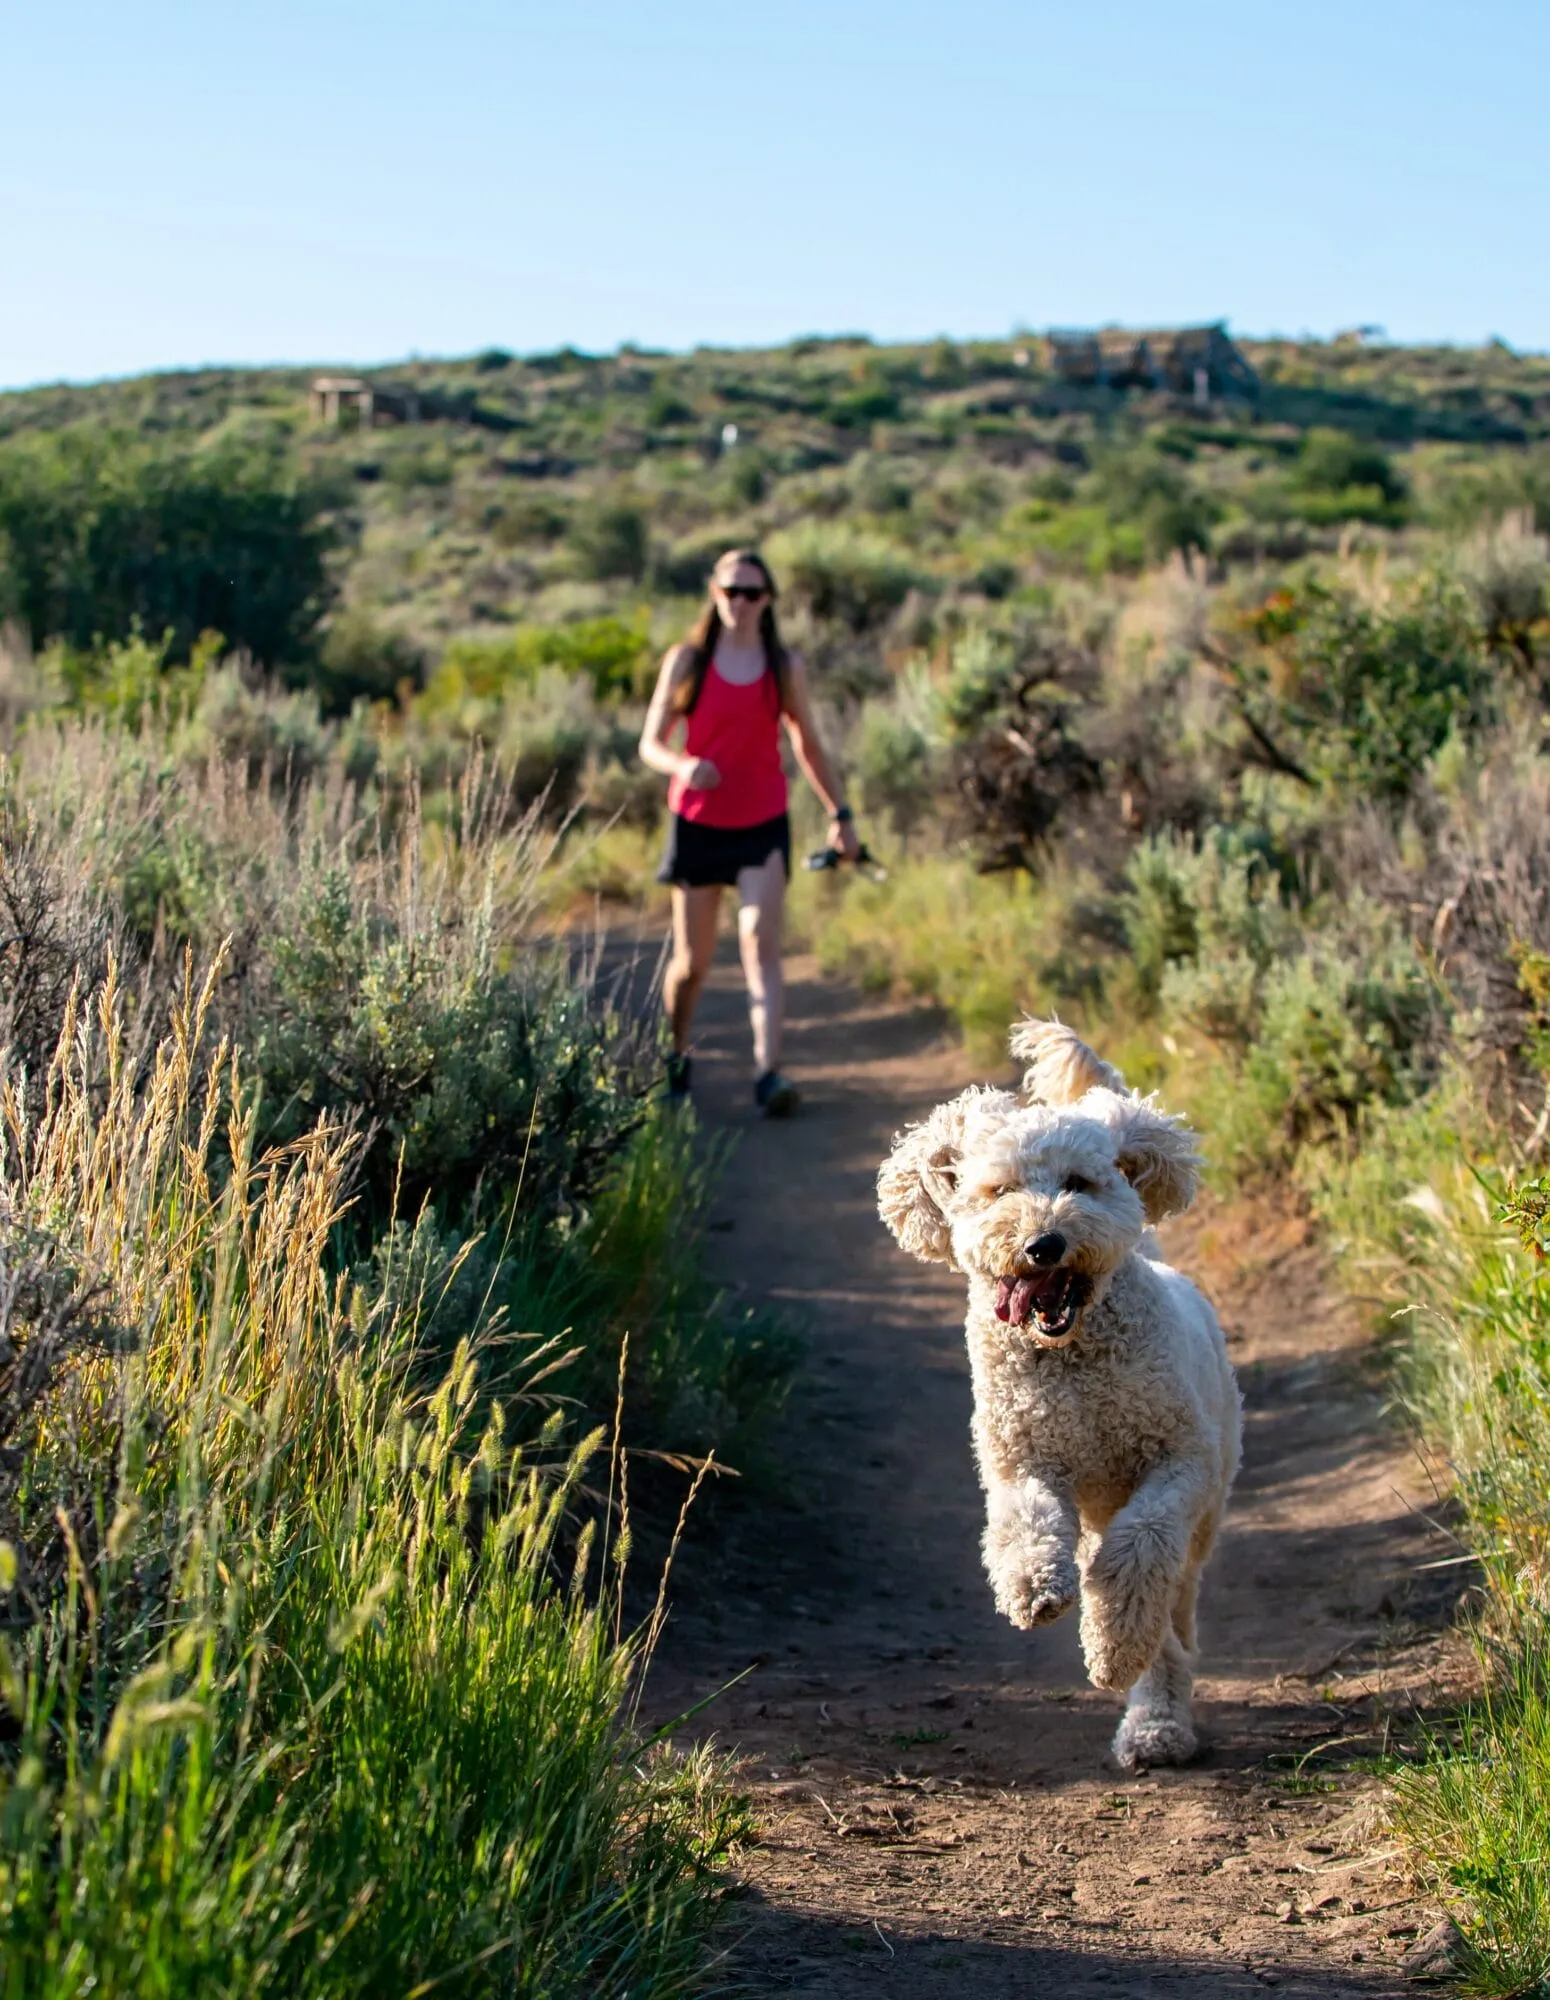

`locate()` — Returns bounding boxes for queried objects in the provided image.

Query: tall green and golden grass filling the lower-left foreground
[0,960,742,2000]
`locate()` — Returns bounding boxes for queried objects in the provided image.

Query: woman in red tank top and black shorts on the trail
[640,548,858,1118]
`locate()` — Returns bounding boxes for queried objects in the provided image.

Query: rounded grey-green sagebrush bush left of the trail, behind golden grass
[236,846,640,1220]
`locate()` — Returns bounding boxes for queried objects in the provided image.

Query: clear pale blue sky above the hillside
[0,0,1550,386]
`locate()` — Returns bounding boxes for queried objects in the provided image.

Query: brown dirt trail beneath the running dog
[650,960,1458,2000]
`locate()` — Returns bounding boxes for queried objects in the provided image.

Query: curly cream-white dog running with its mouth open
[878,1020,1242,1770]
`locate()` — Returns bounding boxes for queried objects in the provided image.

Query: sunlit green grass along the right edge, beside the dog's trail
[1304,1112,1550,2000]
